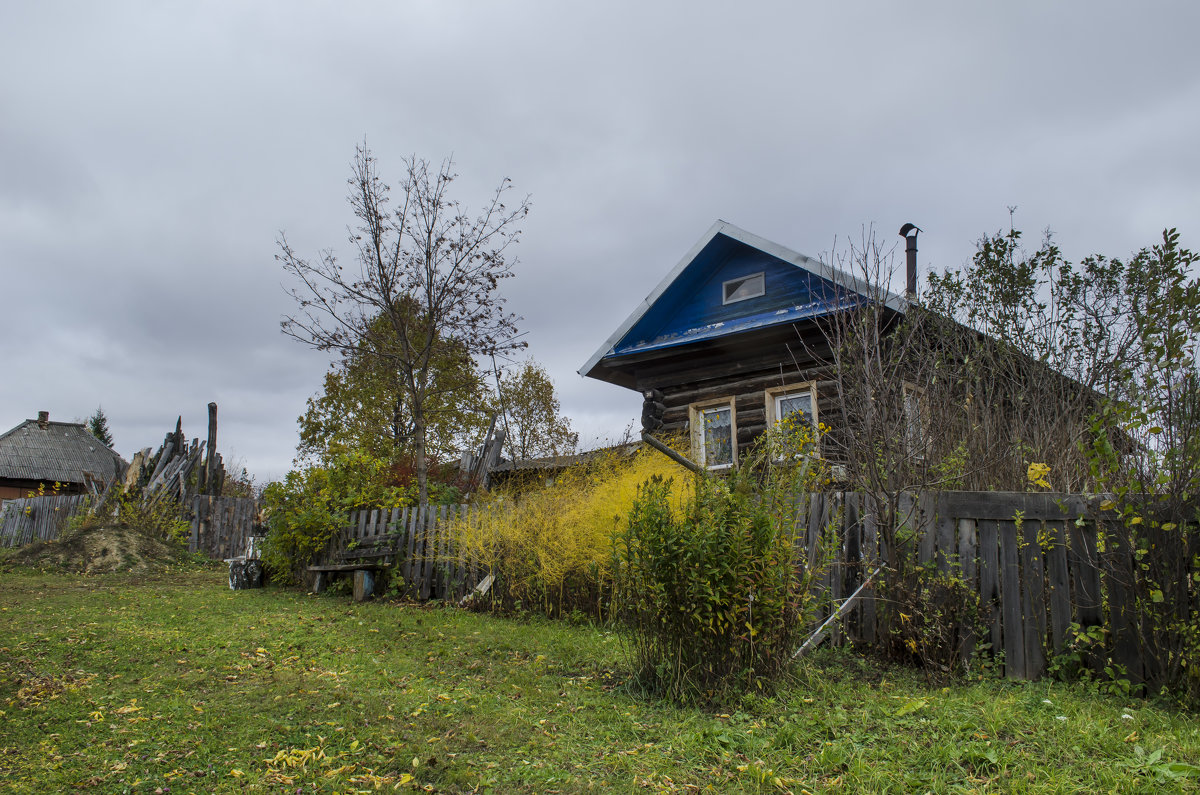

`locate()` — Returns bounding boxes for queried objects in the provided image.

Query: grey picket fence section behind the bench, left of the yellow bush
[314,506,487,599]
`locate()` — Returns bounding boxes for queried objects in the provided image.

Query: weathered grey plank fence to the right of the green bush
[805,491,1200,683]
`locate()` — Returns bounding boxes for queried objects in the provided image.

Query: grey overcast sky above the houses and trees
[0,0,1200,480]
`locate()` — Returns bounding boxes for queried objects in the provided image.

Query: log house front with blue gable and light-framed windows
[580,221,908,468]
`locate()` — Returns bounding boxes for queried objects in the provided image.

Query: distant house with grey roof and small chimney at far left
[0,411,127,502]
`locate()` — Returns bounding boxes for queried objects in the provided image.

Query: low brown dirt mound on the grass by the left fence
[12,525,187,574]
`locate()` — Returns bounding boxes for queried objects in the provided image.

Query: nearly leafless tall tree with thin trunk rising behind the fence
[276,144,529,502]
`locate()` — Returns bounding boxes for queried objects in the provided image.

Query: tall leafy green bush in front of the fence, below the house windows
[613,429,817,703]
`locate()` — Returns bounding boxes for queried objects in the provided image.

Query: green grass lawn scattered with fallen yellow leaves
[0,566,1200,793]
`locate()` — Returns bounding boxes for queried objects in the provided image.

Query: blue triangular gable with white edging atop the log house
[580,221,905,389]
